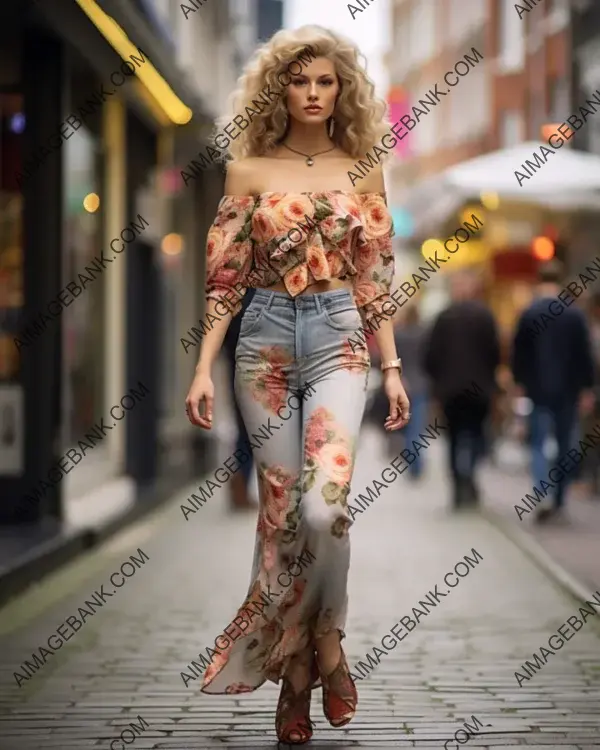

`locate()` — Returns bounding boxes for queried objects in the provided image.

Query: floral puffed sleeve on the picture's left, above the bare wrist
[206,195,255,316]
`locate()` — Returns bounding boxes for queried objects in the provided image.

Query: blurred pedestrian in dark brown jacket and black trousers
[425,271,500,508]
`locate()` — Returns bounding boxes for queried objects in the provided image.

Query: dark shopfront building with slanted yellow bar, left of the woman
[0,0,258,548]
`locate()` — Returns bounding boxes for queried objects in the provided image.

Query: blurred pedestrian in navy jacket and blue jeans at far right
[512,260,595,521]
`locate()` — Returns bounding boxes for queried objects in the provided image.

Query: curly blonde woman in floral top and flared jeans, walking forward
[186,26,409,744]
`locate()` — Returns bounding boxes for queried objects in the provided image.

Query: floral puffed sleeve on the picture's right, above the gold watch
[353,193,395,325]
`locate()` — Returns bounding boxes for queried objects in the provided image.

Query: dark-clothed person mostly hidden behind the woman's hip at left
[223,289,258,510]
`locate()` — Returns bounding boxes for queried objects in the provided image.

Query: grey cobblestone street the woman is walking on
[0,432,600,750]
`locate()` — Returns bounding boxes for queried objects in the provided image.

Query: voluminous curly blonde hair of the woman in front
[212,25,390,161]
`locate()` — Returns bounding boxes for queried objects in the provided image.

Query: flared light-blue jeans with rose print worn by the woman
[202,289,371,694]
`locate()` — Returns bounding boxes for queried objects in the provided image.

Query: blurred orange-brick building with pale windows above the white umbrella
[388,0,571,185]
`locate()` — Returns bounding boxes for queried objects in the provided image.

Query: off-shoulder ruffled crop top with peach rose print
[206,190,394,321]
